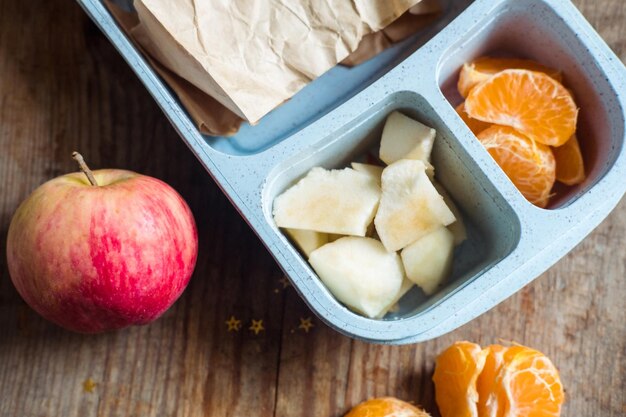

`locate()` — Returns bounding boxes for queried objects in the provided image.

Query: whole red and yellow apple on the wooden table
[7,169,198,333]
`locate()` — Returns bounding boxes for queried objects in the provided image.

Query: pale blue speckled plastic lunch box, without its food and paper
[78,0,626,344]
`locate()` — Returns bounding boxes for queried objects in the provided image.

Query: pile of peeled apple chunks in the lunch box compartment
[274,112,467,318]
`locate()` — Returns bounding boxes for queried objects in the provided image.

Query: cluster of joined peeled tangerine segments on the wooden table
[433,342,565,417]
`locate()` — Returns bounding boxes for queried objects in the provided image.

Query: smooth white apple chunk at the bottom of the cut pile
[309,236,404,318]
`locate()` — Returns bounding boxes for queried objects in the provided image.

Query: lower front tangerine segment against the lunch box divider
[477,126,556,207]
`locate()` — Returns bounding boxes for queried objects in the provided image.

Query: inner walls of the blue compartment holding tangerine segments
[439,0,624,208]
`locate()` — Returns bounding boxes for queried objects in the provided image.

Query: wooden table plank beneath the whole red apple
[0,1,282,417]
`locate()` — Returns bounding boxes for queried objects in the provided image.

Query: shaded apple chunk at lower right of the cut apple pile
[401,227,454,294]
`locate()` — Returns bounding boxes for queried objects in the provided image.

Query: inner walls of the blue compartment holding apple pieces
[263,92,520,319]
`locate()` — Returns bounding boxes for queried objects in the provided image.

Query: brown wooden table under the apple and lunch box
[0,0,626,417]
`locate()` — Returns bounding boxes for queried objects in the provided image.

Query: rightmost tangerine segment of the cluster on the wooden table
[493,346,565,417]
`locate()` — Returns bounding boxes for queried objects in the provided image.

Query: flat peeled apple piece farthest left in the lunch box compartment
[274,168,380,236]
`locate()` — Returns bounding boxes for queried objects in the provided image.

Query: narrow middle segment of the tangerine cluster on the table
[476,345,507,417]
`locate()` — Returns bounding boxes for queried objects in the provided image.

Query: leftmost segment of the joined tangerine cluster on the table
[433,342,487,417]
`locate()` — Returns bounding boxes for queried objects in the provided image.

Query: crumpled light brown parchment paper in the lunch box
[134,0,419,123]
